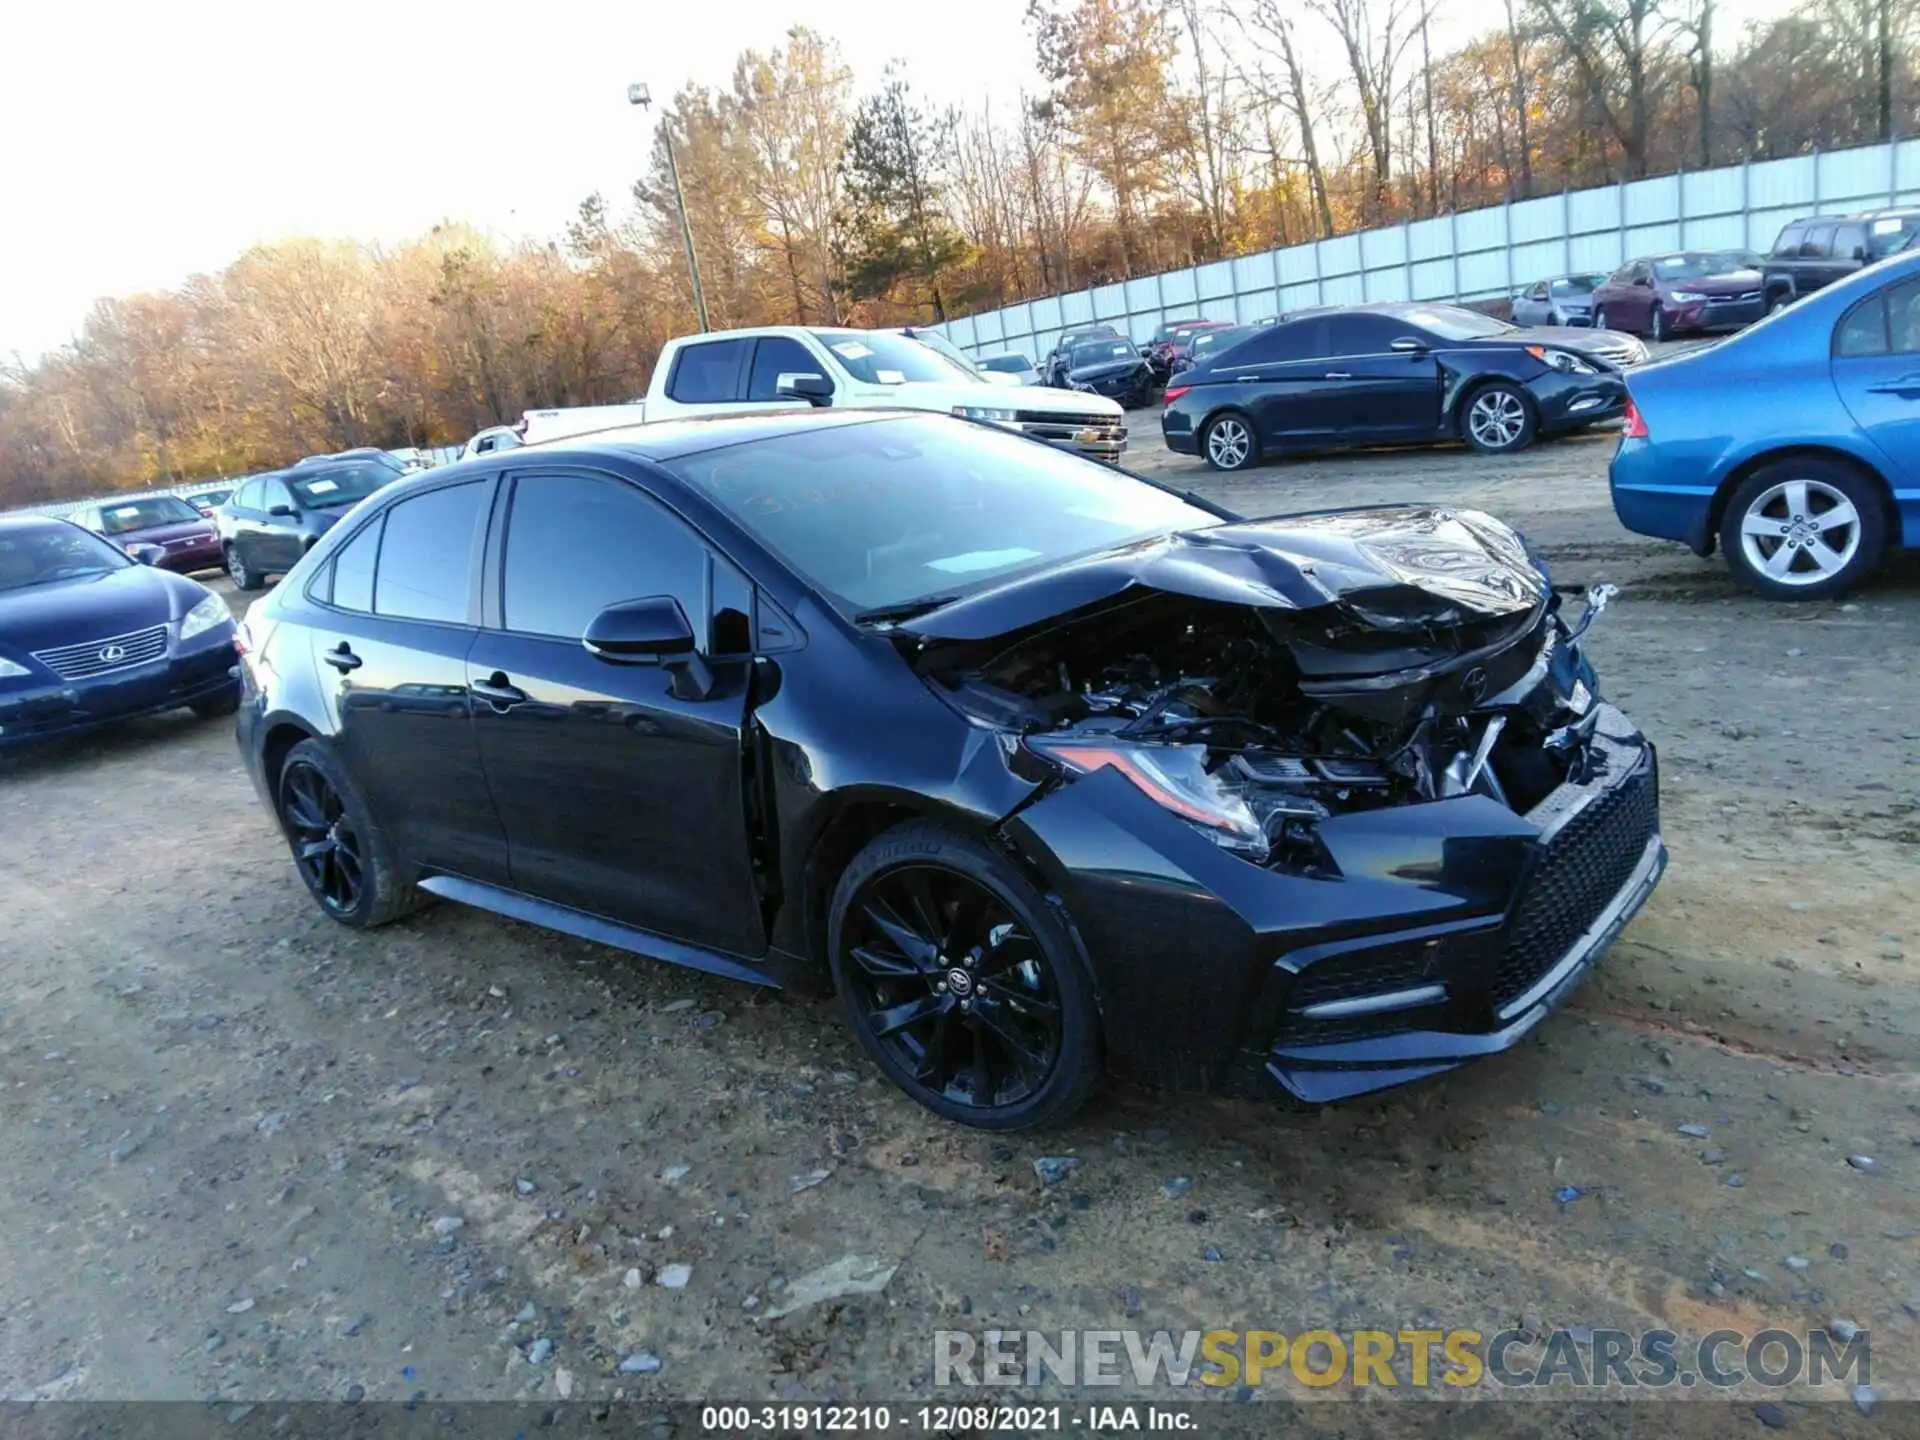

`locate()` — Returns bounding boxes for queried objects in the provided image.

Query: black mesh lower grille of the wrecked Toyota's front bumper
[1492,768,1661,1008]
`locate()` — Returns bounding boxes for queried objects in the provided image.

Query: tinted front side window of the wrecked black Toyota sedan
[501,474,707,641]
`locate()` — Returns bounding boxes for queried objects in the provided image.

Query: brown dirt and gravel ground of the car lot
[0,415,1920,1434]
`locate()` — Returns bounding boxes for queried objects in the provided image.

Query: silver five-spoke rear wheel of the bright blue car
[1720,457,1885,599]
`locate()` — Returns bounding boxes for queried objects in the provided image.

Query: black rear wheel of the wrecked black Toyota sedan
[275,739,422,929]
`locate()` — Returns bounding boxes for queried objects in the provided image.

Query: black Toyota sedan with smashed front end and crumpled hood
[238,411,1667,1129]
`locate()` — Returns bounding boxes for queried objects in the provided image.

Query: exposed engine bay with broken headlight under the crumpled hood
[922,586,1613,870]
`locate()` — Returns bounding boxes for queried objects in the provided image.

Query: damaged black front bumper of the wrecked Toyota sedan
[1008,703,1667,1102]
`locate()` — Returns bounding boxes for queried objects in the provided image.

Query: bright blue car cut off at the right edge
[1611,253,1920,599]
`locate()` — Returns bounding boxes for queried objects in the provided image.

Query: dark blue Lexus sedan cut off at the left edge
[0,516,240,749]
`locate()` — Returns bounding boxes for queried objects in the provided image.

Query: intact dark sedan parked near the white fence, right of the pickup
[1160,303,1647,470]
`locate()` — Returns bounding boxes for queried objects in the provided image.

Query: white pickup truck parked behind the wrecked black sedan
[515,324,1127,461]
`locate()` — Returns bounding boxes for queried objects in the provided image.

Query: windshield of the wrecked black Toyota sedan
[662,417,1219,614]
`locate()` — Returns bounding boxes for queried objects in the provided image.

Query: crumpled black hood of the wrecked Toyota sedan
[897,505,1548,639]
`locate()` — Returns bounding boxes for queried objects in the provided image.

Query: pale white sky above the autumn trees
[0,0,1812,357]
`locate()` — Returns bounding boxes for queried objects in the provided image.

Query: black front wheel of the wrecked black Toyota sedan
[828,820,1100,1131]
